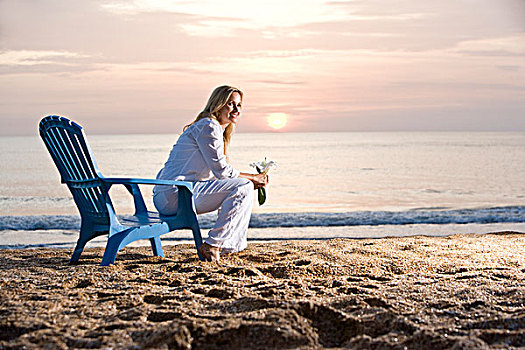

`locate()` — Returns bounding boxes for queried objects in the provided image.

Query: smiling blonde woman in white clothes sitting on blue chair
[153,85,268,261]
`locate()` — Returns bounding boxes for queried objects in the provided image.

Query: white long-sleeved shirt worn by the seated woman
[153,118,239,193]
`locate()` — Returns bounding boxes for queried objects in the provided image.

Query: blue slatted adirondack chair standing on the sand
[39,116,203,265]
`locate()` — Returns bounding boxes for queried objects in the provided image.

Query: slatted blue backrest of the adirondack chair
[40,116,111,217]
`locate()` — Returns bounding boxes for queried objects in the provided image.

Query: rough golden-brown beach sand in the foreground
[0,232,525,349]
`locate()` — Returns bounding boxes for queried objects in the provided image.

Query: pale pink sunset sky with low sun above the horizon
[0,0,525,136]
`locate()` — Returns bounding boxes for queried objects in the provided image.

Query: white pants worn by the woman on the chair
[153,178,254,253]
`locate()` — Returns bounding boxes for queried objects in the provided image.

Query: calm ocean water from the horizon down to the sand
[0,132,525,248]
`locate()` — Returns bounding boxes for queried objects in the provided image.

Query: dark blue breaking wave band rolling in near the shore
[0,206,525,231]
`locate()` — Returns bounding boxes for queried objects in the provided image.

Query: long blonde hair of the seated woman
[184,85,243,156]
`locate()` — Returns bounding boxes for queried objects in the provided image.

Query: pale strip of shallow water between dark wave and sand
[0,223,525,250]
